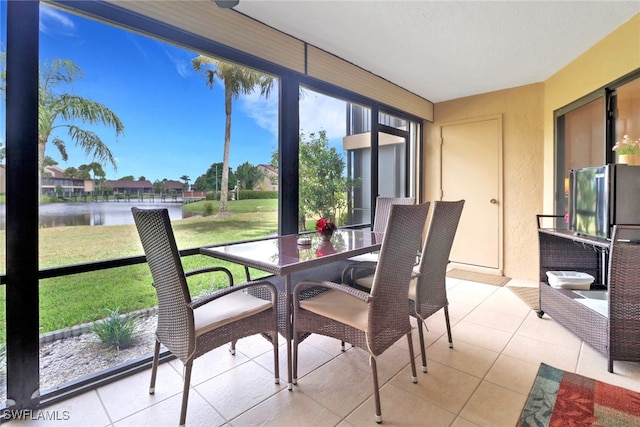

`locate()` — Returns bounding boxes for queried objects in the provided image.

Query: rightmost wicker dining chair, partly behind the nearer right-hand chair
[409,200,464,372]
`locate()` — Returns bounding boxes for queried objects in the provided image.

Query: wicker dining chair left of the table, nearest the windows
[131,207,279,426]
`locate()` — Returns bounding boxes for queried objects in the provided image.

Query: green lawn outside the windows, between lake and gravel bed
[0,199,278,343]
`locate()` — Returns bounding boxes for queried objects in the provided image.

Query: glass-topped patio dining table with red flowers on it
[200,229,383,390]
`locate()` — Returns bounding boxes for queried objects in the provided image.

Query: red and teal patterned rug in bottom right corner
[517,363,640,427]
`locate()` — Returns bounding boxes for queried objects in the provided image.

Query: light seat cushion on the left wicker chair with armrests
[193,291,271,336]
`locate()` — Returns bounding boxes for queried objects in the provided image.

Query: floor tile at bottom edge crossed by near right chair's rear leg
[346,384,456,427]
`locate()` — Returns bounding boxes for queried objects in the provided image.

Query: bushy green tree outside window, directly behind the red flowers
[299,130,351,230]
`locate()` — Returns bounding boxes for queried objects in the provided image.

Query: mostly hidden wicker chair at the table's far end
[342,196,420,288]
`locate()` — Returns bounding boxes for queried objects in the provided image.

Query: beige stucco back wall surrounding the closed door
[424,83,544,280]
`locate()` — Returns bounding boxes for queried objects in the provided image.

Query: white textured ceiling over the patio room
[234,0,640,102]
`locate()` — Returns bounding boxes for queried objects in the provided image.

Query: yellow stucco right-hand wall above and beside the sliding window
[544,14,640,212]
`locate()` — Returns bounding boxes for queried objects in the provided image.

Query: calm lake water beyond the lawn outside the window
[0,201,198,230]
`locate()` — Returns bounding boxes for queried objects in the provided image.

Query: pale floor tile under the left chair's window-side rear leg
[97,363,182,422]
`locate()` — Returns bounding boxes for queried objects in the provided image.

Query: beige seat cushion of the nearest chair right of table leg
[300,289,369,332]
